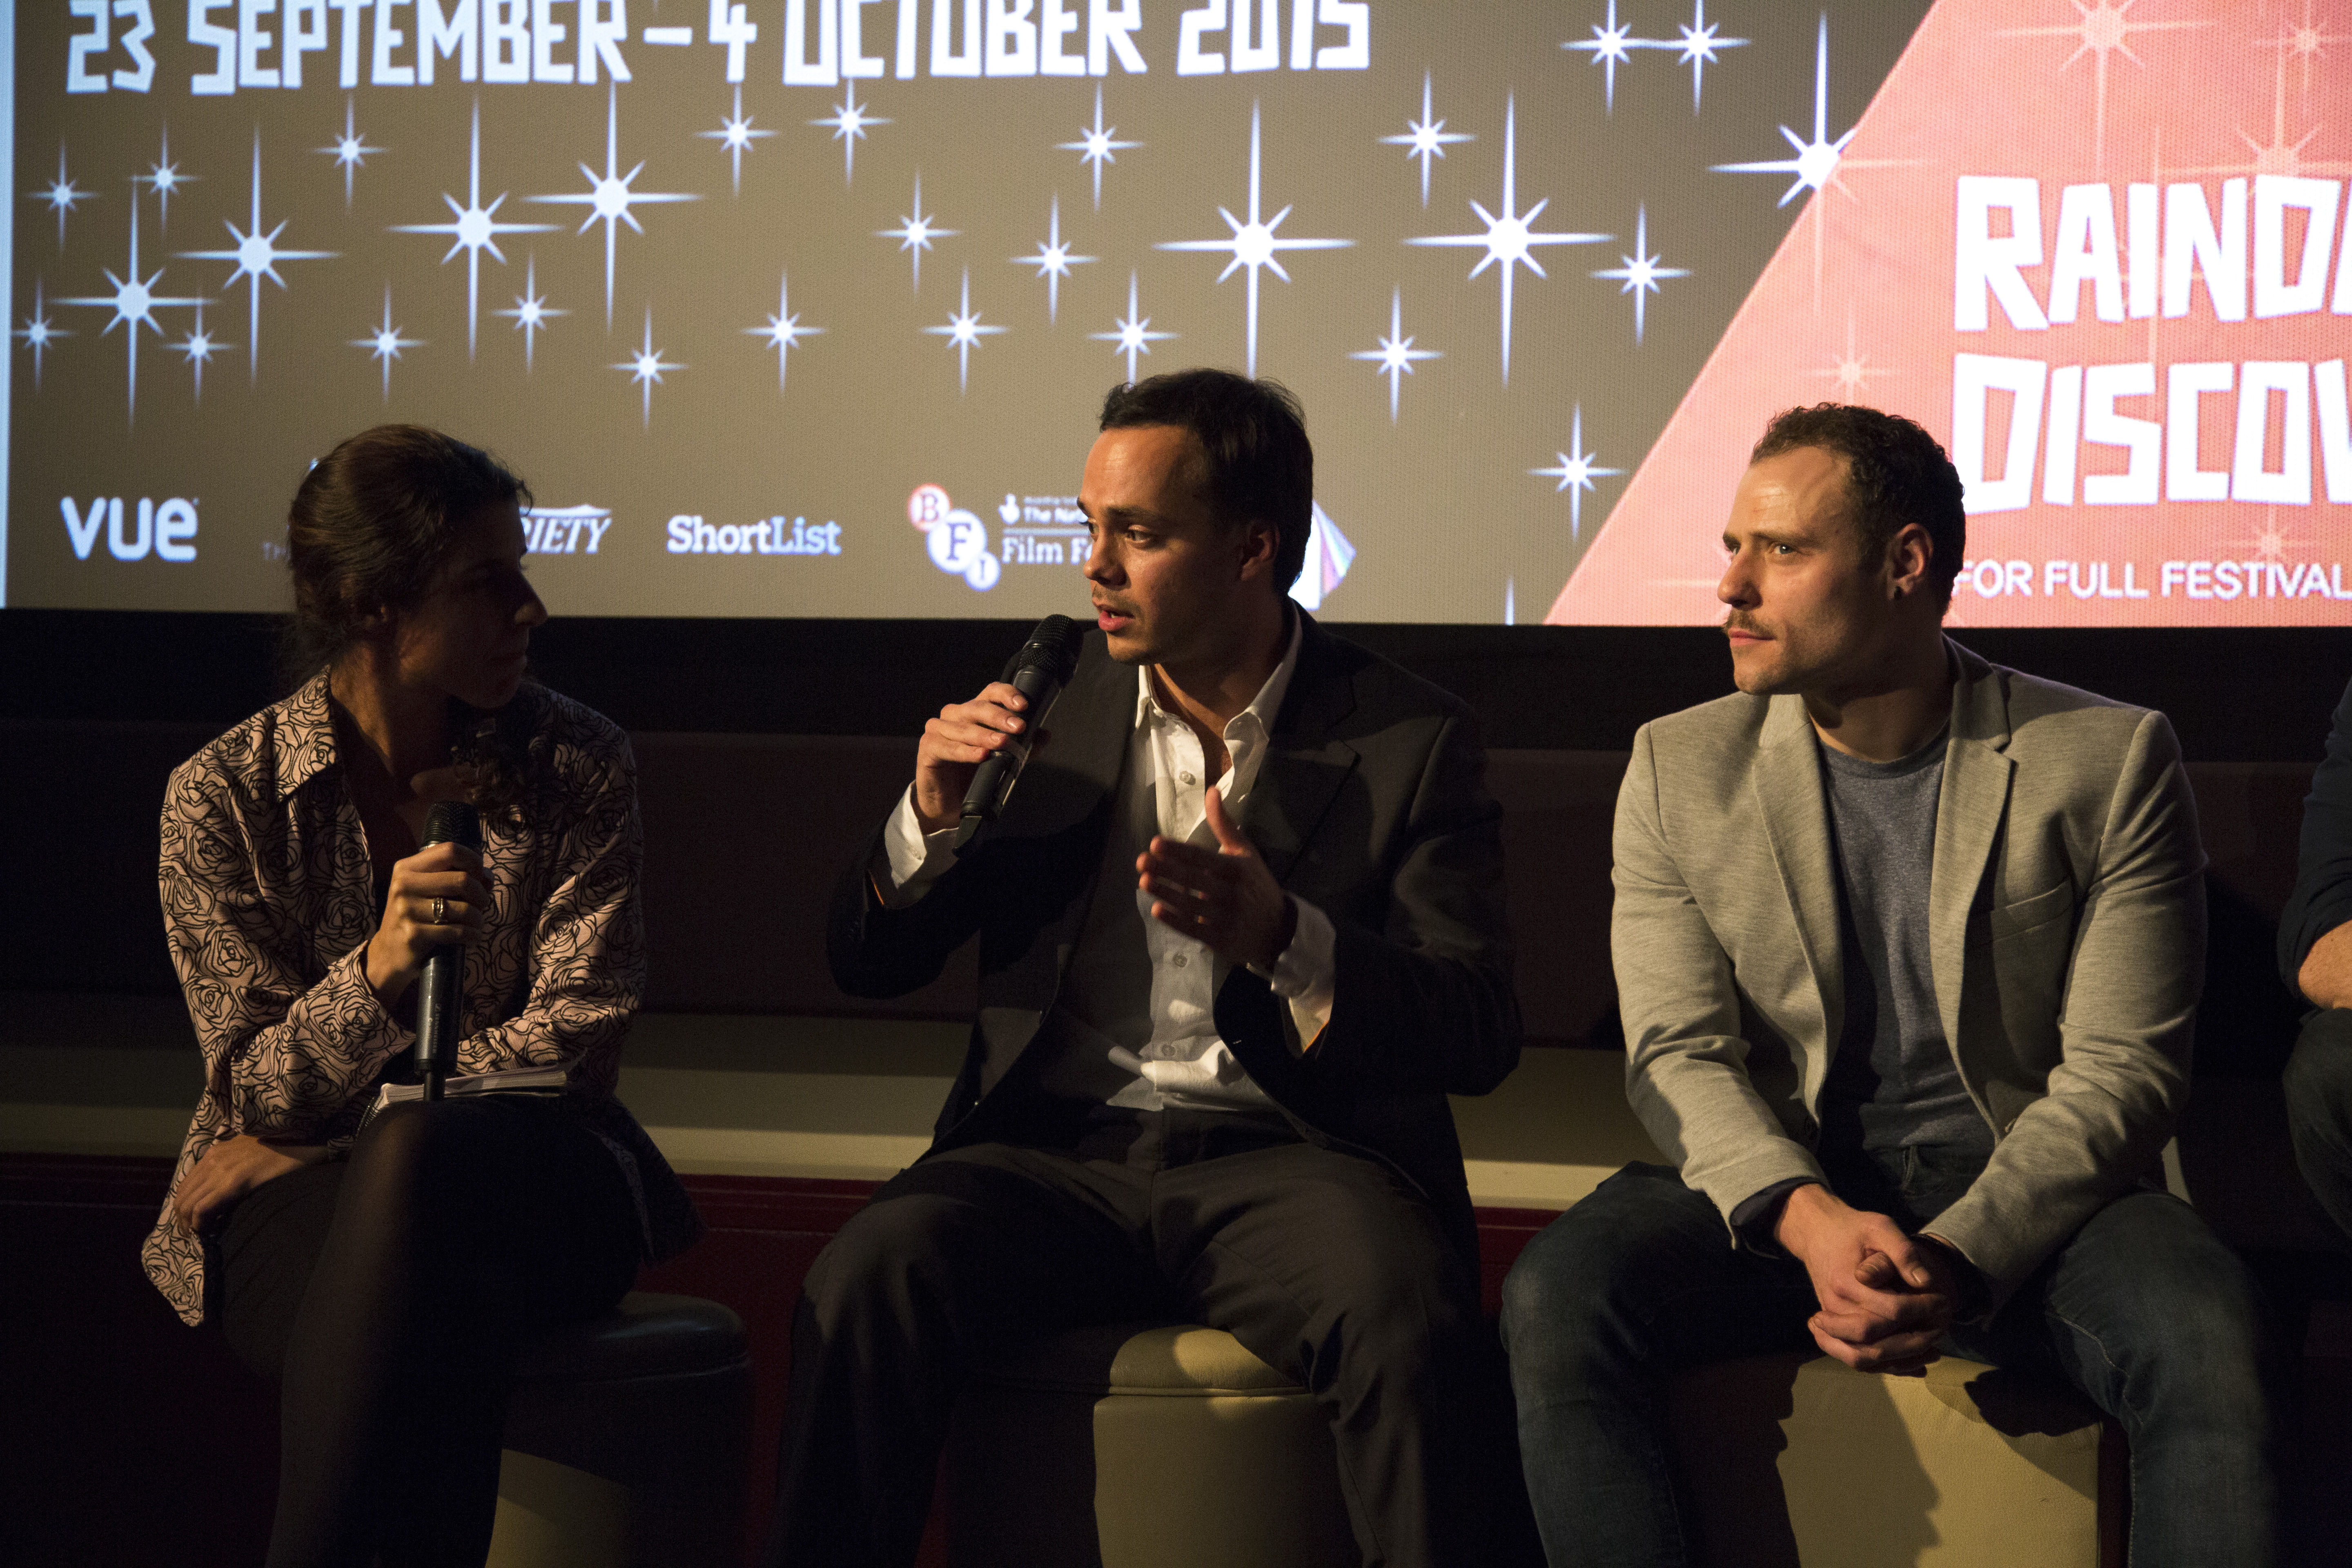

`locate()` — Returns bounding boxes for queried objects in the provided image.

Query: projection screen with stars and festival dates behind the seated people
[0,0,2352,625]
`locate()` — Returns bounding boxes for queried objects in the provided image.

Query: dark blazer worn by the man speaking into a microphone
[828,611,1519,1258]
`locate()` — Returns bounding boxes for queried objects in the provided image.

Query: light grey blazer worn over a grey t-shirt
[1611,644,2204,1298]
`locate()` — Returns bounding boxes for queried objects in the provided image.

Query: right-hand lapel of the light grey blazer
[1926,644,2018,1058]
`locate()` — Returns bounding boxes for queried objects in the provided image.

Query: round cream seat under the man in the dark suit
[948,1323,1359,1568]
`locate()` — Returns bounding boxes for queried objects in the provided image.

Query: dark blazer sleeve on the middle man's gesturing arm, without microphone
[1305,715,1519,1096]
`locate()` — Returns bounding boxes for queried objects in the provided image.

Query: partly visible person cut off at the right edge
[2279,686,2352,1234]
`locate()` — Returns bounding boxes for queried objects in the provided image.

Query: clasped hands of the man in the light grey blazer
[1773,1185,1959,1373]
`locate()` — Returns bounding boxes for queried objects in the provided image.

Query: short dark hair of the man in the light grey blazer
[1748,402,1969,604]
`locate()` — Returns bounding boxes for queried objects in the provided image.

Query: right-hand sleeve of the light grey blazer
[1933,712,2206,1300]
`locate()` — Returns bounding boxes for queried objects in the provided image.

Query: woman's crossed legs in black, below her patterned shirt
[214,1096,640,1568]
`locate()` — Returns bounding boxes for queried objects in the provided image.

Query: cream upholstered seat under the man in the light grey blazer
[1668,1354,2129,1568]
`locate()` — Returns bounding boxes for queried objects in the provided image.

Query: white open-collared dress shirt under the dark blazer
[882,616,1336,1109]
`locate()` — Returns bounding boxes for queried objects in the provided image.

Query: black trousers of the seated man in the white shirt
[764,1112,1524,1568]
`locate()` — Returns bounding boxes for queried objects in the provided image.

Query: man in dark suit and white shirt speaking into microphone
[767,372,1519,1568]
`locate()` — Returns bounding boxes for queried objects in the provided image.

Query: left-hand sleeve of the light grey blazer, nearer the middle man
[1609,726,1825,1239]
